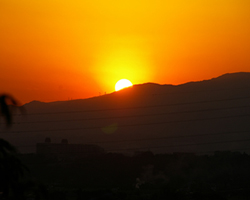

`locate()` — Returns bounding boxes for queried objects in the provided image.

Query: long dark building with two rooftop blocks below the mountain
[36,138,105,156]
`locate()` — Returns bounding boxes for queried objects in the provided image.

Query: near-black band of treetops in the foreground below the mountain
[5,152,250,200]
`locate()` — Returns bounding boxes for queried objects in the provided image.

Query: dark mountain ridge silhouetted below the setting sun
[0,72,250,153]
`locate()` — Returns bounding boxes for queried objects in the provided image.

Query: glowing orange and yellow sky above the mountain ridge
[0,0,250,103]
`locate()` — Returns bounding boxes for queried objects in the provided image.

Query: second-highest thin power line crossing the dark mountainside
[10,106,250,124]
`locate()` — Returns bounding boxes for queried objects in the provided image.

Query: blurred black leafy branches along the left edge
[0,94,47,200]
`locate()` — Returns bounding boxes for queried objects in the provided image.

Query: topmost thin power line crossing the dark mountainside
[16,96,250,116]
